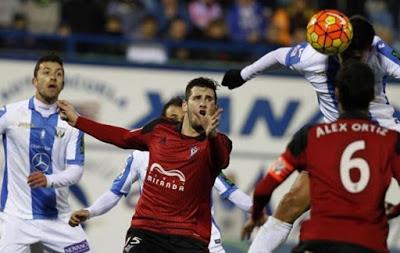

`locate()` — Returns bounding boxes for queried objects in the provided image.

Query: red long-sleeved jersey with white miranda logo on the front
[77,117,232,244]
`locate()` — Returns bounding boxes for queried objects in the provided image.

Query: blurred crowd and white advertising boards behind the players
[0,0,400,253]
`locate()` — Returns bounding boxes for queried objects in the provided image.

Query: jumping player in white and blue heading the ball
[222,13,400,252]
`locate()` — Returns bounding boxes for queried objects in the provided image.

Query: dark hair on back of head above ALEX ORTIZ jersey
[336,60,375,111]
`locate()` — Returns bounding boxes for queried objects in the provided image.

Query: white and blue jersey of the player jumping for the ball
[241,36,400,131]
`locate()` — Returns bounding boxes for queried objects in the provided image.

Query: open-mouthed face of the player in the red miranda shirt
[184,86,217,131]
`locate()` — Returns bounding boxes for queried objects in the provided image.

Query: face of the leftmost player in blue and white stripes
[32,62,64,104]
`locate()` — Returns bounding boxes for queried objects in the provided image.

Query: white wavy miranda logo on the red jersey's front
[146,163,186,191]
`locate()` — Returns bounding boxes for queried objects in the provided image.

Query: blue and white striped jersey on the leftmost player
[0,97,84,219]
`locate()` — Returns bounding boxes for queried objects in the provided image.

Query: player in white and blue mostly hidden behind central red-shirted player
[70,98,252,253]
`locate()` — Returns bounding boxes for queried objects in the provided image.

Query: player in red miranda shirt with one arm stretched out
[58,77,232,253]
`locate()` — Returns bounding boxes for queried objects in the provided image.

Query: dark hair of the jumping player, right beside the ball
[343,15,375,58]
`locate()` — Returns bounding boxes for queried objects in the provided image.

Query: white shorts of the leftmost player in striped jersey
[0,213,90,253]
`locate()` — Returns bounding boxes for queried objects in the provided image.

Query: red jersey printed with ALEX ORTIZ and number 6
[283,115,400,252]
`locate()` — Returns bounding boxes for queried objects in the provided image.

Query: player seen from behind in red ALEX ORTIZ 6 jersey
[249,61,400,253]
